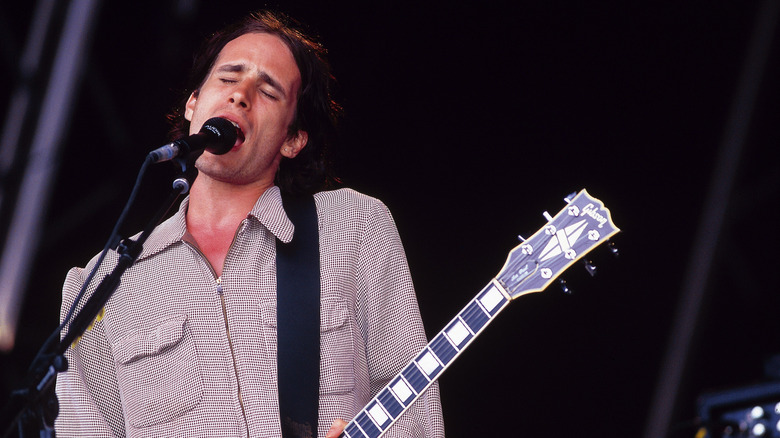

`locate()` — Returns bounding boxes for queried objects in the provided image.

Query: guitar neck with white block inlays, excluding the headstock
[341,280,511,438]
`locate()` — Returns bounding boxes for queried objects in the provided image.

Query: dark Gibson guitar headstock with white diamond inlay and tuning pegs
[496,189,620,299]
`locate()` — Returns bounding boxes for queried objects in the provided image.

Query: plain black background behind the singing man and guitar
[0,0,780,437]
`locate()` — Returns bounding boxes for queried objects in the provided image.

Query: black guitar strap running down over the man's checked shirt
[276,195,320,438]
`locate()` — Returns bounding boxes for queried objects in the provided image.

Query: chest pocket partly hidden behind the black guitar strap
[260,298,356,395]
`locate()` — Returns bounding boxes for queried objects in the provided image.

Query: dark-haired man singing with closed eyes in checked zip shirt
[56,7,444,438]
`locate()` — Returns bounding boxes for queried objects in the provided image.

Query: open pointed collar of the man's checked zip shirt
[133,186,295,260]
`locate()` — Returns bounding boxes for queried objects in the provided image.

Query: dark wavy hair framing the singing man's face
[168,11,341,195]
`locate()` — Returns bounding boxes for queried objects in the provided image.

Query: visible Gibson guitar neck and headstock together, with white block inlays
[341,190,620,438]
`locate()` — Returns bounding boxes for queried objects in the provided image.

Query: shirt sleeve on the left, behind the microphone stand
[55,268,125,437]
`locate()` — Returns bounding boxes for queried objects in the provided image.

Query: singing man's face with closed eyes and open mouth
[184,33,308,185]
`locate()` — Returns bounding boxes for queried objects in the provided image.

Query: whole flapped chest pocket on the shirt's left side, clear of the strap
[112,315,203,428]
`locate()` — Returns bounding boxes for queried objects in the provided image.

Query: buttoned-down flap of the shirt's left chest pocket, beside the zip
[112,315,187,365]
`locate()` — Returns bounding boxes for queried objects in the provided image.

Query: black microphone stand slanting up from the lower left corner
[2,159,195,438]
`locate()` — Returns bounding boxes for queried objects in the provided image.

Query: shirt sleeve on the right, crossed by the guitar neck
[358,201,444,438]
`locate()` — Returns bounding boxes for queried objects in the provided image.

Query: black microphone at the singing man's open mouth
[146,117,237,163]
